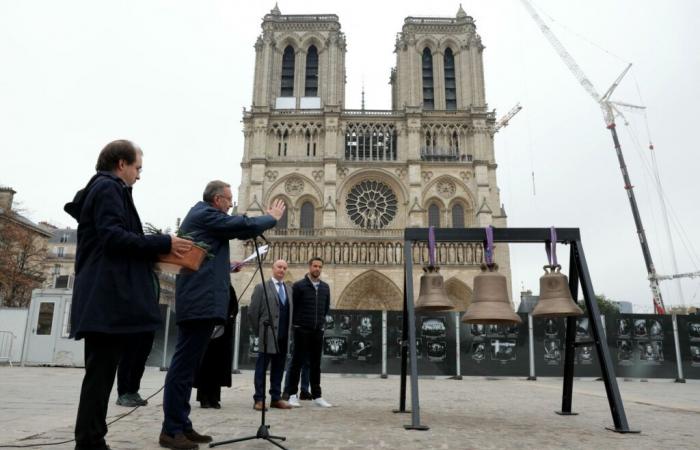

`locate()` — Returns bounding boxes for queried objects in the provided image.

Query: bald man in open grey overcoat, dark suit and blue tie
[248,259,294,411]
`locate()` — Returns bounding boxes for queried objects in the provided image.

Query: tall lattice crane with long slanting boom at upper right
[521,0,665,314]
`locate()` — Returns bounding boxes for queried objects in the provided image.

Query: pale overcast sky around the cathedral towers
[0,0,700,312]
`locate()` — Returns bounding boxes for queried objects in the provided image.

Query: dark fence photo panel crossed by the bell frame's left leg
[387,311,457,376]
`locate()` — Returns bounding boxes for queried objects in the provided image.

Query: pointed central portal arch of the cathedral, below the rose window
[335,270,403,311]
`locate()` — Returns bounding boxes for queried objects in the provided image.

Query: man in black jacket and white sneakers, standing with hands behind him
[287,257,333,408]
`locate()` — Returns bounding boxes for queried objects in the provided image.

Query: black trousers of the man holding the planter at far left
[75,333,133,450]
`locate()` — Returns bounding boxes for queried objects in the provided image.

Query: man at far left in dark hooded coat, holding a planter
[64,140,192,449]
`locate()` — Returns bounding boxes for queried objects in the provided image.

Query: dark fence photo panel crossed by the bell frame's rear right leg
[524,316,601,377]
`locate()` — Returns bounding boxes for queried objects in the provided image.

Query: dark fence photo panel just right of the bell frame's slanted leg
[605,314,677,378]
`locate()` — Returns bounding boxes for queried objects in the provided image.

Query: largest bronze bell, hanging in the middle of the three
[462,264,522,324]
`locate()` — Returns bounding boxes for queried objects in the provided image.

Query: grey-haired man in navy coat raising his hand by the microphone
[159,181,285,449]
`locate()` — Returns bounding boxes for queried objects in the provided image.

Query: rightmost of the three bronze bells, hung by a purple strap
[532,264,583,317]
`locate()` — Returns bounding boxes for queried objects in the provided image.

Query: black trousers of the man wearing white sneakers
[287,327,323,398]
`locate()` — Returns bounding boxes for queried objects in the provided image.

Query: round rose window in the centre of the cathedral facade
[345,180,397,228]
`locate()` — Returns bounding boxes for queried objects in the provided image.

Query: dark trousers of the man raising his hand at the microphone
[163,320,214,436]
